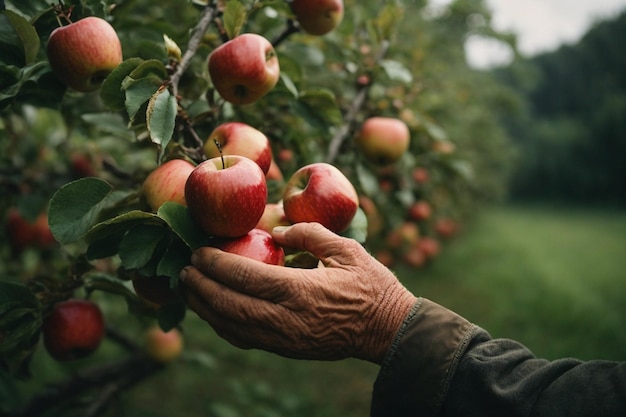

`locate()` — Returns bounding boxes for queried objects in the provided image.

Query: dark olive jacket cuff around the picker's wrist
[371,298,478,417]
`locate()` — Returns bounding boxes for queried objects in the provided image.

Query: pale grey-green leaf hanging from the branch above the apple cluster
[146,88,178,156]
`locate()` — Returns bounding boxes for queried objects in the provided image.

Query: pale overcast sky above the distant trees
[431,0,626,67]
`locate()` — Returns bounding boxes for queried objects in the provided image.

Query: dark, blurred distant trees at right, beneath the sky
[498,13,626,204]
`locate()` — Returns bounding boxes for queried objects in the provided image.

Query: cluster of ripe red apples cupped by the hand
[140,122,359,272]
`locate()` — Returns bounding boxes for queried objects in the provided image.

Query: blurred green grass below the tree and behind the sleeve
[15,206,626,417]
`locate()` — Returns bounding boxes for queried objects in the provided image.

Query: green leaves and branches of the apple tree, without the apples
[0,0,513,411]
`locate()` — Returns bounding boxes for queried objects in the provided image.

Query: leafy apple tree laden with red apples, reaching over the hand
[0,0,514,415]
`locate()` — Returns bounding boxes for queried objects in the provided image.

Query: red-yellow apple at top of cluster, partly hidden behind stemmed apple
[204,122,272,174]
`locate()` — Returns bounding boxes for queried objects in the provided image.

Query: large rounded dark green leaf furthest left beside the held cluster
[48,178,113,244]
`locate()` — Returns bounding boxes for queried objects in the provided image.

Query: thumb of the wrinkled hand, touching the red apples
[272,223,344,260]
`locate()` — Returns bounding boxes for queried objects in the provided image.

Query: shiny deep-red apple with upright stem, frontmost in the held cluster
[185,155,267,237]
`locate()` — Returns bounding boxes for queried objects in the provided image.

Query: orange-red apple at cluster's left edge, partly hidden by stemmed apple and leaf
[141,159,195,212]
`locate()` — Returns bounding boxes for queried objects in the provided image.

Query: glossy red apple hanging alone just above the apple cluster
[208,33,280,104]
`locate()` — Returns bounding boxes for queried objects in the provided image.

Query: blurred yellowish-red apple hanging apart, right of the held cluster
[355,117,411,166]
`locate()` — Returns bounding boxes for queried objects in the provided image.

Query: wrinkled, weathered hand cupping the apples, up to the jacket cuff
[181,223,416,364]
